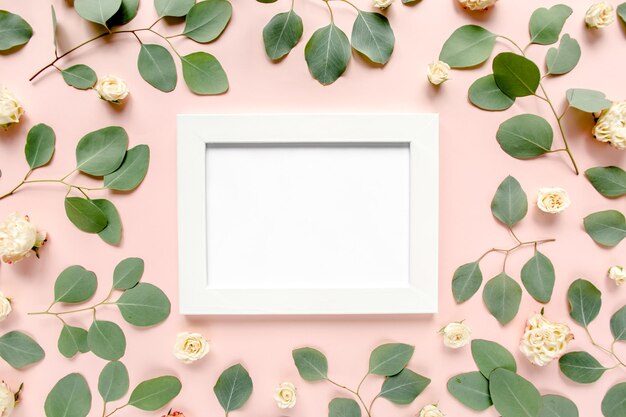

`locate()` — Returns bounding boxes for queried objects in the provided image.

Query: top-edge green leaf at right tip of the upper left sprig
[183,0,233,43]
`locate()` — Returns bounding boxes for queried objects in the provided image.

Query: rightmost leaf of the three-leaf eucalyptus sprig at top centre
[352,10,396,65]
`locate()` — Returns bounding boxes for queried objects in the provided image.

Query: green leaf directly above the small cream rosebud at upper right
[439,25,496,68]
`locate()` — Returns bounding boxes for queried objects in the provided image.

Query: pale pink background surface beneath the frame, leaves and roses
[0,0,626,417]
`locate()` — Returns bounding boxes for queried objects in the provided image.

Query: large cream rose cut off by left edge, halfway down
[0,213,46,264]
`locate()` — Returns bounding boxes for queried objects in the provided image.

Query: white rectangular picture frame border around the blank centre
[177,114,439,315]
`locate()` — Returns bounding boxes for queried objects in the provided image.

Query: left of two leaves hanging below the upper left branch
[137,44,178,93]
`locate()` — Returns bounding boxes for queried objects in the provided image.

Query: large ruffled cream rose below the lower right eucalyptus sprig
[520,314,574,366]
